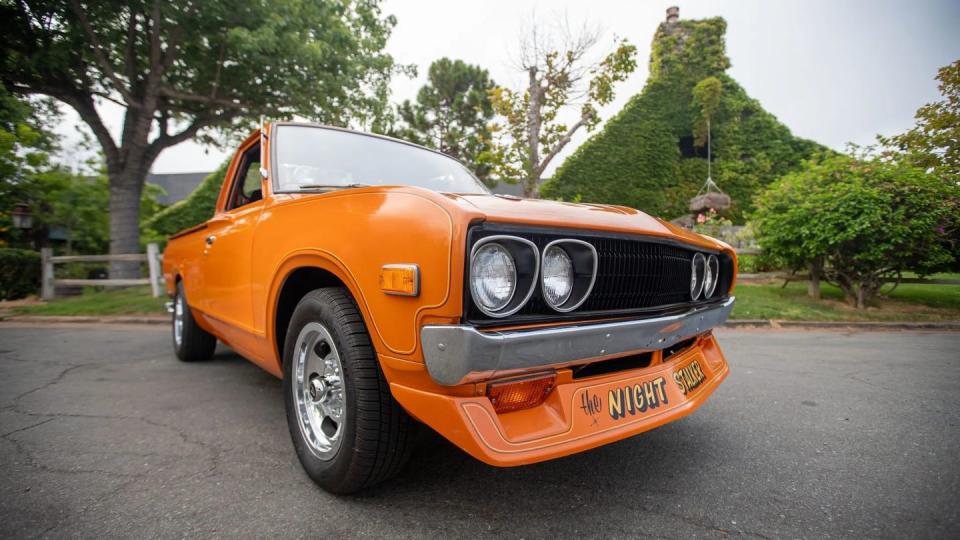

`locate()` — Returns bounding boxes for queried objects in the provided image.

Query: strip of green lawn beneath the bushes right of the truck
[731,274,960,321]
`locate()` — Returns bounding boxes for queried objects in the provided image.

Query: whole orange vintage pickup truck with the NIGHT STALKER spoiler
[163,122,737,493]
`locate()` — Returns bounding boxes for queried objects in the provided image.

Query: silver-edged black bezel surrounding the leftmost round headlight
[467,235,540,319]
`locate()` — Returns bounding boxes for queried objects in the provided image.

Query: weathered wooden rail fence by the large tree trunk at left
[40,243,163,300]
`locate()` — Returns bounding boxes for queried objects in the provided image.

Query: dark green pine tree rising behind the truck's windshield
[392,58,495,182]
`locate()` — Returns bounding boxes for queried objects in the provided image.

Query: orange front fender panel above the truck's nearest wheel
[253,190,464,361]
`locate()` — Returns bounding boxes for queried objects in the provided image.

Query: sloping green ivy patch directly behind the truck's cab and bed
[143,161,229,244]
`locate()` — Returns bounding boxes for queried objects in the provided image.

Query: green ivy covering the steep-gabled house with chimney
[542,18,826,222]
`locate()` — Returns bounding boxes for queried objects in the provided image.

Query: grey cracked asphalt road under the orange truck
[0,324,960,538]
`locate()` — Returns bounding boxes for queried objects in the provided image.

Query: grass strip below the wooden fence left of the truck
[13,286,169,316]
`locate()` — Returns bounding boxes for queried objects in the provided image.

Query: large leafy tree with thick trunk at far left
[0,0,395,275]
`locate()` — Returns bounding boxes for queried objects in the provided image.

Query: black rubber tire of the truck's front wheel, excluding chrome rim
[283,287,416,494]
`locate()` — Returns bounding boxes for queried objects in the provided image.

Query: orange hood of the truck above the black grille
[447,194,722,249]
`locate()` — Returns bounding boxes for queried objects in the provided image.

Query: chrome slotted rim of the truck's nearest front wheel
[291,322,346,461]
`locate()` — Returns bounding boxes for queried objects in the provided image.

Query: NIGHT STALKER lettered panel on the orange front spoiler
[574,357,707,427]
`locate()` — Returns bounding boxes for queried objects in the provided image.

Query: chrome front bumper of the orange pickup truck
[420,297,734,385]
